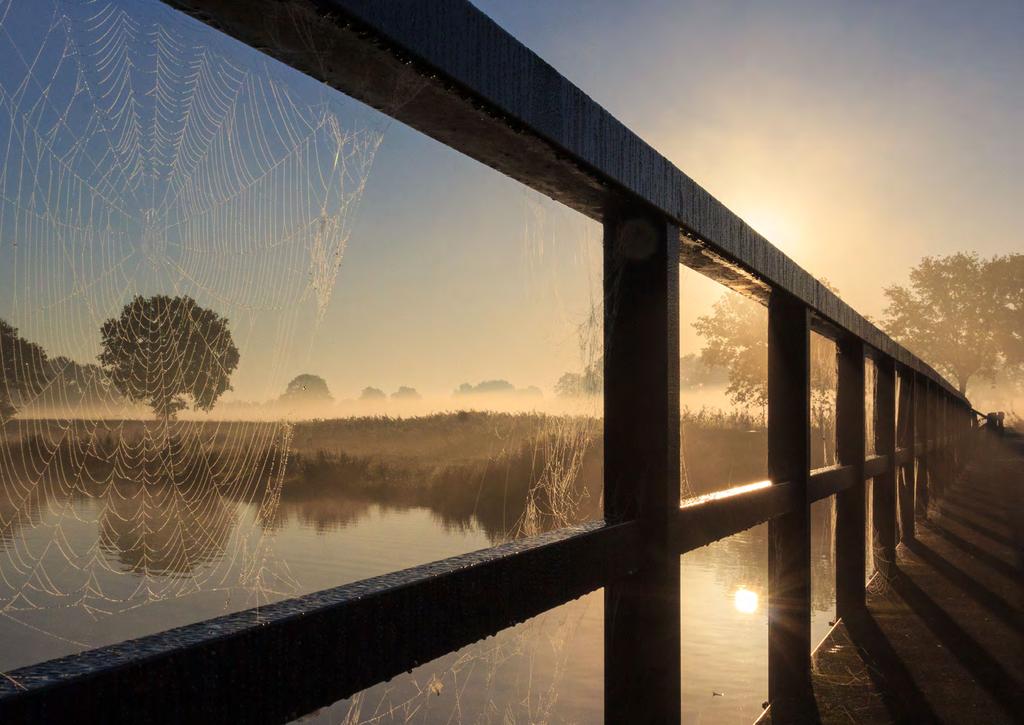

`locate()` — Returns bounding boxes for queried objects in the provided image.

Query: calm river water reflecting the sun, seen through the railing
[0,475,834,723]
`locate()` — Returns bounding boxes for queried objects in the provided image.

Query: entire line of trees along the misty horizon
[6,253,1024,423]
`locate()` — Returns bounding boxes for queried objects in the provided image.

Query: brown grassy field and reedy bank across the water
[0,410,821,540]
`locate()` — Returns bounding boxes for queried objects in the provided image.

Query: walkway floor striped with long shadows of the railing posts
[798,435,1024,725]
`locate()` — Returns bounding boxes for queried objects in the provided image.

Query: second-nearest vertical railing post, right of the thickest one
[768,290,812,722]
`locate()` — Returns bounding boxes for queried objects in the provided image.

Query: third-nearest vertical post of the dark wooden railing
[836,338,866,617]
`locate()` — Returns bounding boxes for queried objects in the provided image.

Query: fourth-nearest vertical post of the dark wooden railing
[871,357,896,578]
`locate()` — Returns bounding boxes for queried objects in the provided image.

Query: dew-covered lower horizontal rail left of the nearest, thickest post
[0,522,640,725]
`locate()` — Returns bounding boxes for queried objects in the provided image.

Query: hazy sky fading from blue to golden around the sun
[0,0,1024,400]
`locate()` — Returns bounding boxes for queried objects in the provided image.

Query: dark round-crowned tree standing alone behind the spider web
[99,295,239,423]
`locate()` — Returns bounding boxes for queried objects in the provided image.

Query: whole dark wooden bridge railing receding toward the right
[0,0,975,723]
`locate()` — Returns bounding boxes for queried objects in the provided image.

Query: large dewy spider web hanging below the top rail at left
[0,0,382,646]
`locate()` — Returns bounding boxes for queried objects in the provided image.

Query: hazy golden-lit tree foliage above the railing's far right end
[885,252,1024,393]
